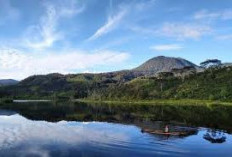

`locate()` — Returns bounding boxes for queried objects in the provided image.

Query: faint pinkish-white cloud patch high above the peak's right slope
[159,23,212,40]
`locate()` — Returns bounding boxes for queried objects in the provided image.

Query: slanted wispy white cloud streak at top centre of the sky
[88,8,126,40]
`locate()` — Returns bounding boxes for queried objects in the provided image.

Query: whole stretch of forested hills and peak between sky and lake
[0,57,232,101]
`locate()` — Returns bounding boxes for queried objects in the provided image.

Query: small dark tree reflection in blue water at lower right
[203,129,226,143]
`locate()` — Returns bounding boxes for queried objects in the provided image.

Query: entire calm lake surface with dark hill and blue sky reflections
[0,102,232,157]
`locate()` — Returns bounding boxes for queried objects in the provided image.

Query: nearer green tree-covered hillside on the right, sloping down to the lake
[91,67,232,101]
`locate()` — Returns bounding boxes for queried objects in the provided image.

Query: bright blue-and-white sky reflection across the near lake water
[0,114,232,157]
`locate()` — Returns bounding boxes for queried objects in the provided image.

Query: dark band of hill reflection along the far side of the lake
[0,102,232,133]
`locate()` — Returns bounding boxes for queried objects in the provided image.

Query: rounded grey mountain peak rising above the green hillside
[133,56,199,75]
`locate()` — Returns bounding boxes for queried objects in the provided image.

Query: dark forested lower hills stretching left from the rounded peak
[0,71,142,98]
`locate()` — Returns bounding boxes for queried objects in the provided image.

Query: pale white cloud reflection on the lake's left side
[0,114,130,151]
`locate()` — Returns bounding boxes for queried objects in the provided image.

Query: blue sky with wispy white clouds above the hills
[0,0,232,80]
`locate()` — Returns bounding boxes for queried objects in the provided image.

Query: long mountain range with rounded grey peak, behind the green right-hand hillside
[0,56,197,98]
